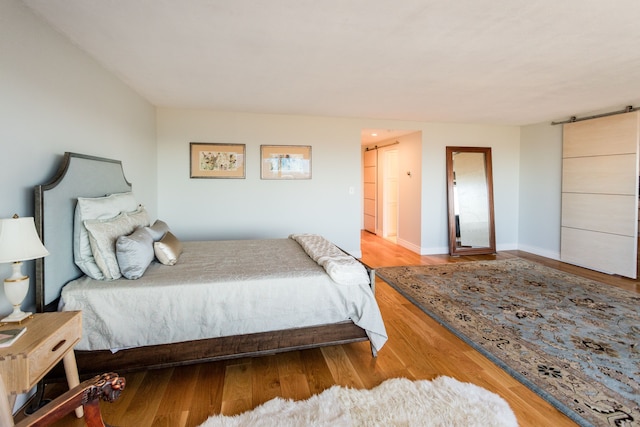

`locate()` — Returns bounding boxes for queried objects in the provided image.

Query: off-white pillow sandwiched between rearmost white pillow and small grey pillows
[84,206,149,280]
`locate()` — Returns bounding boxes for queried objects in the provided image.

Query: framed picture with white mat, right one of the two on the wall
[260,145,311,179]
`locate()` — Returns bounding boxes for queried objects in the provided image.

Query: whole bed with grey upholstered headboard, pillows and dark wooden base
[35,153,387,376]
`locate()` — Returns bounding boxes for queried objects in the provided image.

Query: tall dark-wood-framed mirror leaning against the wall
[447,147,495,255]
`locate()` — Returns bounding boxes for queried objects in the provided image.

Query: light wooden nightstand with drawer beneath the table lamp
[0,311,83,417]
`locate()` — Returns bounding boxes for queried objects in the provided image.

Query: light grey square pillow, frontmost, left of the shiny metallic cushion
[116,227,155,280]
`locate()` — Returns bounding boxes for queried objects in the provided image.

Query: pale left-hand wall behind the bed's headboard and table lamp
[0,0,157,315]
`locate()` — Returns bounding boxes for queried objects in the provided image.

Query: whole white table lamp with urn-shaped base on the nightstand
[0,215,49,322]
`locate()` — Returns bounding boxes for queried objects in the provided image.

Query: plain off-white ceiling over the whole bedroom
[23,0,640,125]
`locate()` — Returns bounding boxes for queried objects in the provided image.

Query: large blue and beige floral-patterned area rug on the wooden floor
[376,259,640,426]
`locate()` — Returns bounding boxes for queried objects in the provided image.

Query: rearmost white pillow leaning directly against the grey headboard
[73,192,138,280]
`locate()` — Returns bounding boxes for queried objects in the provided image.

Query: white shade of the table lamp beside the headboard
[0,217,49,263]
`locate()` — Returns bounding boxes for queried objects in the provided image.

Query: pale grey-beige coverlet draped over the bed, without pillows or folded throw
[61,239,387,350]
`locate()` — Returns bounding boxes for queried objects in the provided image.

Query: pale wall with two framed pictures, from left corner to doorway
[158,108,362,256]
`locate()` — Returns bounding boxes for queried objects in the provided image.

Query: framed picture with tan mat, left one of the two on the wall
[189,142,245,178]
